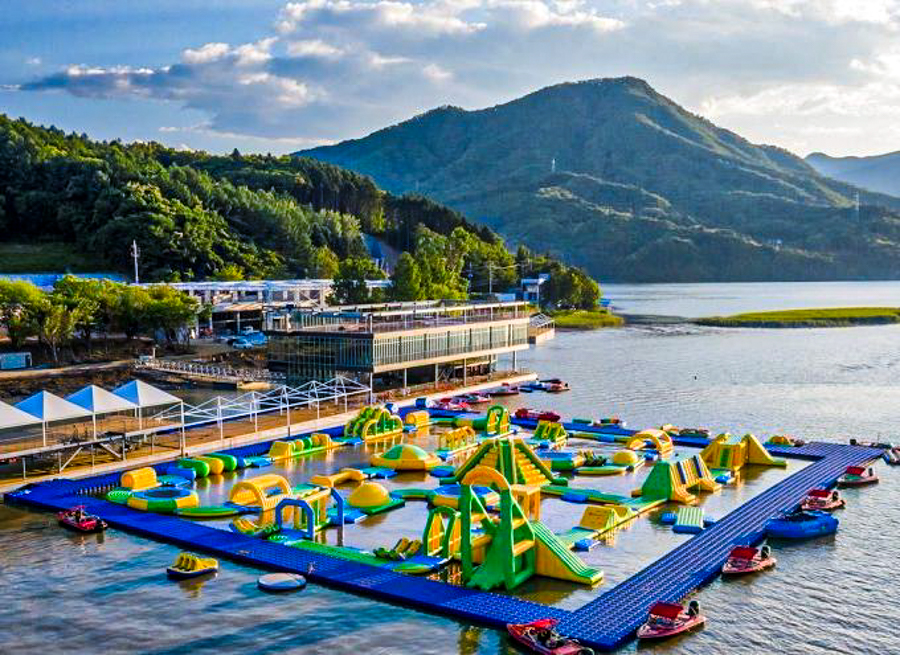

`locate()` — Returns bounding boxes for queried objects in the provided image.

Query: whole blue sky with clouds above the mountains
[0,0,900,156]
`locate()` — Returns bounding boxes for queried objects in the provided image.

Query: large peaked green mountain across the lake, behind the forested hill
[296,77,900,281]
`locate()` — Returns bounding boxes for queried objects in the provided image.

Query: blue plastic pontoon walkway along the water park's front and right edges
[6,426,882,650]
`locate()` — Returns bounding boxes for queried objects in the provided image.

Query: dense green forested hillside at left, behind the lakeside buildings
[0,115,596,308]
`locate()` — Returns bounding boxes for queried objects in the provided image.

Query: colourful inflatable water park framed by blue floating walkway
[6,399,890,654]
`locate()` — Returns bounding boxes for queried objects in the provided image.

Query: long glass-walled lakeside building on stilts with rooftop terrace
[266,302,529,387]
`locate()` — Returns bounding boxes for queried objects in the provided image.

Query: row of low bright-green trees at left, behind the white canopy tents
[0,275,201,364]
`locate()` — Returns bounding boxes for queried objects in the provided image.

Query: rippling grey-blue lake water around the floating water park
[0,282,900,655]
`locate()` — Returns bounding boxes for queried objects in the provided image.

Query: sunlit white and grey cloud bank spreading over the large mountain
[14,0,900,152]
